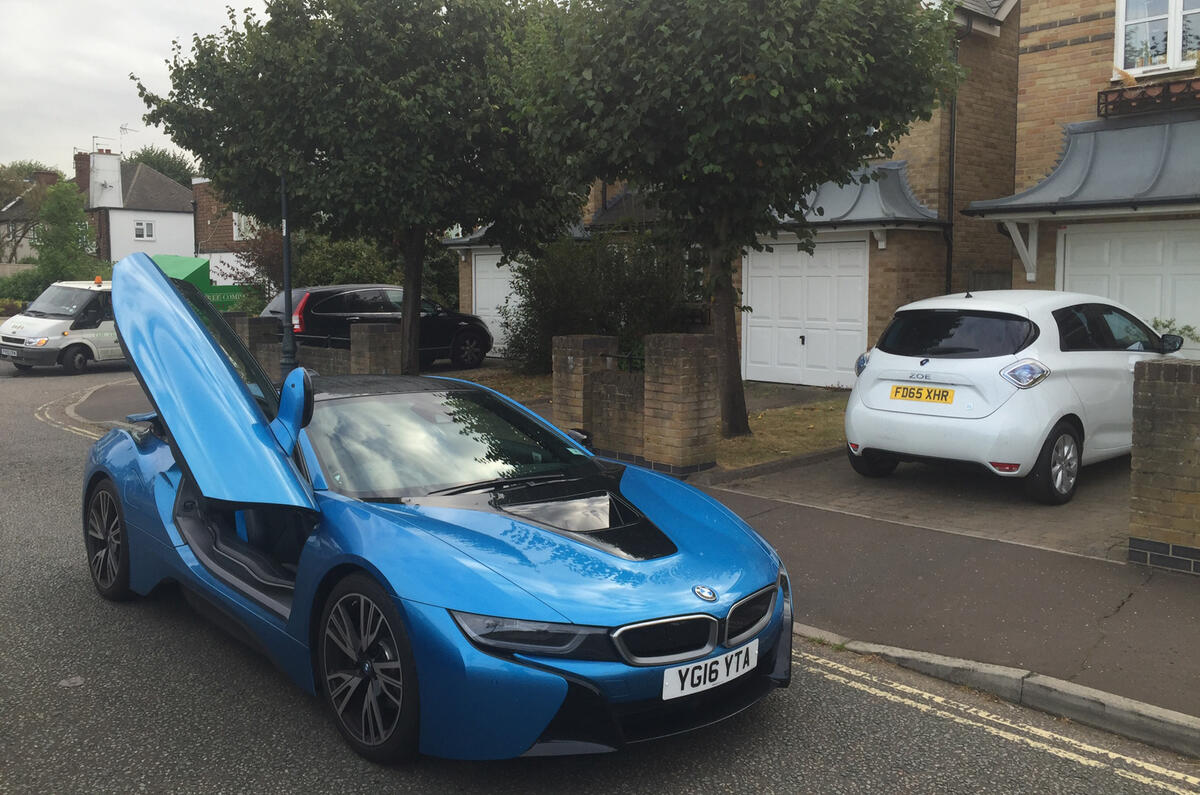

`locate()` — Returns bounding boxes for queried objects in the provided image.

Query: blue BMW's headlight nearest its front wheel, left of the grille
[450,610,617,659]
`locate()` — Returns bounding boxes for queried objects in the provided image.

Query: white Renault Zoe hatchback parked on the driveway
[846,289,1183,504]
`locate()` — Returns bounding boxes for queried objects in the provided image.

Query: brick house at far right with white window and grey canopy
[966,0,1200,338]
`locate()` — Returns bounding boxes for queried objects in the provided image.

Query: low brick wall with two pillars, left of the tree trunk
[553,334,720,474]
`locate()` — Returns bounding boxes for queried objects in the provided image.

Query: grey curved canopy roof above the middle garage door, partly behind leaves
[780,160,944,228]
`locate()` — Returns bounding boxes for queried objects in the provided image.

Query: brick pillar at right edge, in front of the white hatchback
[1129,359,1200,574]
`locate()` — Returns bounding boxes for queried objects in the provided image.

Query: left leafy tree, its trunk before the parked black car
[134,0,581,373]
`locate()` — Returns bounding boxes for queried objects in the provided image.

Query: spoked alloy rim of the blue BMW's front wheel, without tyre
[322,592,404,746]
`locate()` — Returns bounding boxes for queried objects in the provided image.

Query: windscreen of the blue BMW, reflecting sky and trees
[306,390,595,501]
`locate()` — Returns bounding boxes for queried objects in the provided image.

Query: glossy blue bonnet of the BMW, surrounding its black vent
[372,467,780,627]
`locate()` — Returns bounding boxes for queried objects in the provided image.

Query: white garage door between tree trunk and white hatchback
[742,240,866,387]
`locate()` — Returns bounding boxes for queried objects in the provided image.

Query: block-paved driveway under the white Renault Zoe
[718,450,1129,561]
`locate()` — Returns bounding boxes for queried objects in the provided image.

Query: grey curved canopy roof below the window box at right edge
[962,110,1200,217]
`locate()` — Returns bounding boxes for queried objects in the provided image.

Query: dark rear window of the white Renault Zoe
[876,310,1038,359]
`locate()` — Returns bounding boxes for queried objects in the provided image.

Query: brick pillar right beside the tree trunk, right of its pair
[642,334,720,474]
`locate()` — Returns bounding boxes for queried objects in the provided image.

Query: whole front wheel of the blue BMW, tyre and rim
[317,574,420,765]
